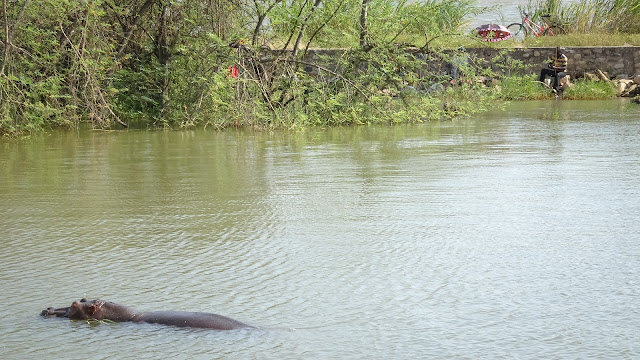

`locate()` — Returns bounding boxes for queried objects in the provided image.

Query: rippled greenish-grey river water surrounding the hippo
[0,101,640,359]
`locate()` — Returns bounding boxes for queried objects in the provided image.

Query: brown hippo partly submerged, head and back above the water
[40,299,252,330]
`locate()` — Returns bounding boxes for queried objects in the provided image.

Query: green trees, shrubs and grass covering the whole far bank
[0,0,640,134]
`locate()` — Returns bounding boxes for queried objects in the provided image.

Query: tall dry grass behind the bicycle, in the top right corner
[522,0,640,34]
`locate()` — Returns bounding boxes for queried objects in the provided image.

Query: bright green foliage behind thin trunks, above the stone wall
[264,0,478,48]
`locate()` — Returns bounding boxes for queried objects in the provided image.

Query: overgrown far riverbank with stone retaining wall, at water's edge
[0,43,640,135]
